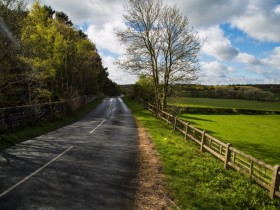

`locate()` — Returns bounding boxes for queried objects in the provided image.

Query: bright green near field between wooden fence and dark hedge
[180,114,280,165]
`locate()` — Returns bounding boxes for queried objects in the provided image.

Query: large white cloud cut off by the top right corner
[231,0,280,42]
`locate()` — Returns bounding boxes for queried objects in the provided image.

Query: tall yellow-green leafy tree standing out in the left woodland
[21,1,56,104]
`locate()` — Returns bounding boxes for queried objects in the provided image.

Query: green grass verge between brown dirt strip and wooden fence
[125,99,280,210]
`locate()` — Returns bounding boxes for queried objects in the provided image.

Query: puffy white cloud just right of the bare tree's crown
[199,25,238,61]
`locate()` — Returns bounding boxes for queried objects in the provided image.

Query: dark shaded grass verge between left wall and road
[0,99,102,150]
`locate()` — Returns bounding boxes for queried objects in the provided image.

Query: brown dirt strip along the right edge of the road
[135,127,177,210]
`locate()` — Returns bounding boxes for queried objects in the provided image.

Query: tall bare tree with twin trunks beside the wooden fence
[116,0,200,109]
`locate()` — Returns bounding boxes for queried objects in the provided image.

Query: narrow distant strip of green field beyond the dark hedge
[168,97,280,111]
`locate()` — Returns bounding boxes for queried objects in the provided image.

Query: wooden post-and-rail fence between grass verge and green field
[143,102,280,198]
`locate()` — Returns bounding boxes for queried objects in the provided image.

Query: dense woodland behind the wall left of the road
[0,0,118,107]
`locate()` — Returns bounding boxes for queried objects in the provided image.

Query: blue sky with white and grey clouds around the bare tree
[27,0,280,85]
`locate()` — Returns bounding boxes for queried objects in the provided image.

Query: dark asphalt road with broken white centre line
[0,98,138,210]
